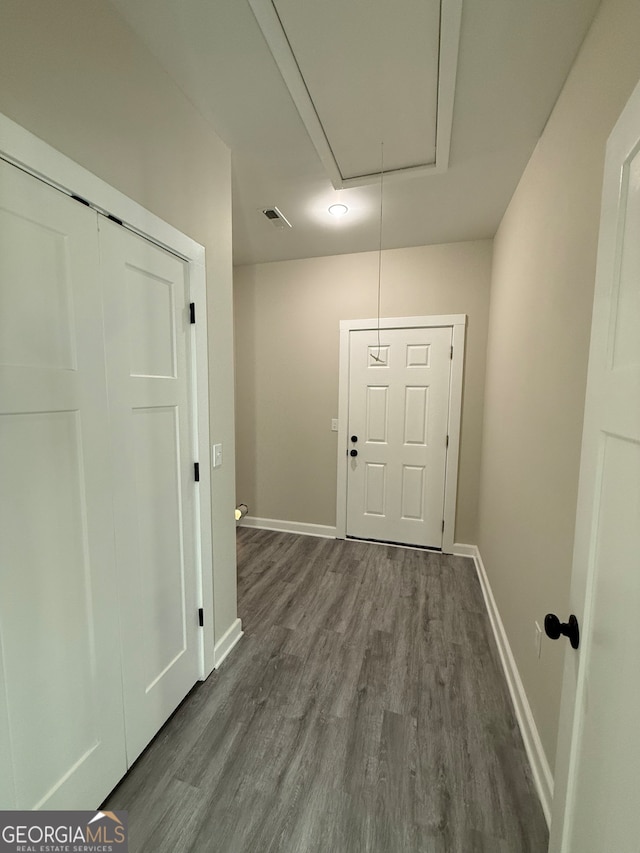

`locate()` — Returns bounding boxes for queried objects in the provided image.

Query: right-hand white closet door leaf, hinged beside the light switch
[99,218,199,764]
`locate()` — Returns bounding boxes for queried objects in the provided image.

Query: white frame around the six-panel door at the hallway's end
[336,314,467,554]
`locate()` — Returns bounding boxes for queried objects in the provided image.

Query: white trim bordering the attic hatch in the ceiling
[249,0,463,189]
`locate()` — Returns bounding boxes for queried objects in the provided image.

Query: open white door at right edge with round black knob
[550,78,640,853]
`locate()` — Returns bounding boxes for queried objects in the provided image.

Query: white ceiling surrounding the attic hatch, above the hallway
[111,0,600,264]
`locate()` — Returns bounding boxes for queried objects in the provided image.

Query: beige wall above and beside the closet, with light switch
[0,0,236,639]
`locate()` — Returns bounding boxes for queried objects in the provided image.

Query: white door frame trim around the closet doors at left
[0,113,214,679]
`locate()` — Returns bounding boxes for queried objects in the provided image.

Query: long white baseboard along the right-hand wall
[470,545,553,826]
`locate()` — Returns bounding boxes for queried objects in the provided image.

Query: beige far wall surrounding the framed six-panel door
[234,240,491,543]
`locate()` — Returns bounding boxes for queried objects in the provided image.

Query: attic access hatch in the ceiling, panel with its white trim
[249,0,462,188]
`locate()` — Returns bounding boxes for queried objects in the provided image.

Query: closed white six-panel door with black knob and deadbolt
[346,327,452,548]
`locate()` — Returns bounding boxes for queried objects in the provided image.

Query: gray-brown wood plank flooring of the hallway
[105,528,548,853]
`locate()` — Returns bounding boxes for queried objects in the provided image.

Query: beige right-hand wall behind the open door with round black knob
[478,0,640,769]
